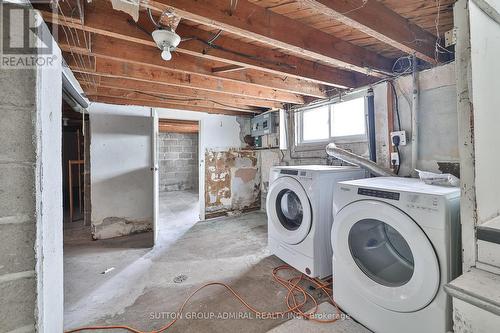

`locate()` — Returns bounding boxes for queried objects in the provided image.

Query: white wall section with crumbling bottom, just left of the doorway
[89,104,153,238]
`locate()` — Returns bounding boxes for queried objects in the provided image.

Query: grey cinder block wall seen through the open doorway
[158,132,198,192]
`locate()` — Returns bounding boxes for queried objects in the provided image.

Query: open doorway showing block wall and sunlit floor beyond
[157,119,200,244]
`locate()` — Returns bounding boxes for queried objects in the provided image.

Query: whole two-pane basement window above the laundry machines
[295,95,367,146]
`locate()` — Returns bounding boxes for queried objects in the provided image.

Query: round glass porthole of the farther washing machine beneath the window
[276,189,304,231]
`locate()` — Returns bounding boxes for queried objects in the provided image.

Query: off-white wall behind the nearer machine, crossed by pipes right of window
[374,63,459,176]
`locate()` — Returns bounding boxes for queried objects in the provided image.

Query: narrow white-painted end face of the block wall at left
[36,15,64,333]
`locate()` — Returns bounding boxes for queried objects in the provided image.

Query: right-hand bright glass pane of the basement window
[332,97,366,137]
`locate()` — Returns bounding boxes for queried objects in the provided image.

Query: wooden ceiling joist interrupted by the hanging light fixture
[42,0,365,88]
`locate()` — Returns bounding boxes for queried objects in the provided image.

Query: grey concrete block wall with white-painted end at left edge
[0,7,63,333]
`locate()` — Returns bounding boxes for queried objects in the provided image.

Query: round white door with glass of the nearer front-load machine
[332,200,440,312]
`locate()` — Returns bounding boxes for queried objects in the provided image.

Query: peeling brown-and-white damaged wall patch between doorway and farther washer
[205,149,261,218]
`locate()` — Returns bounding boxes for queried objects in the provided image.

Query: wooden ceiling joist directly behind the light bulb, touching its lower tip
[59,35,327,98]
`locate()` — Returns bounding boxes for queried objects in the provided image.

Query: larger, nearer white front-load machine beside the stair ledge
[331,177,461,333]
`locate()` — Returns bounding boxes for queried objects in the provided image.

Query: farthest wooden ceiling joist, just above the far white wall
[91,96,252,116]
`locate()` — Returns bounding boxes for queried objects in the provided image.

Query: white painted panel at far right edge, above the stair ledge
[469,1,500,224]
